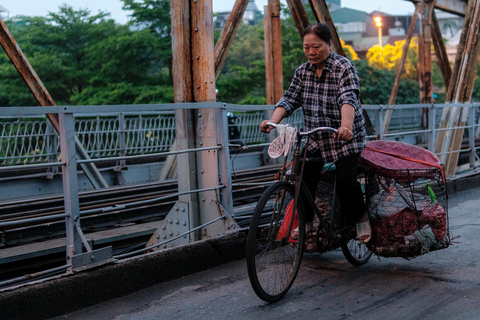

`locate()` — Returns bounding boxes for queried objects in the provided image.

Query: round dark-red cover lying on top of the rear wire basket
[359,140,440,182]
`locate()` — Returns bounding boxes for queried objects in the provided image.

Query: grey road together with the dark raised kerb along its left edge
[0,176,480,320]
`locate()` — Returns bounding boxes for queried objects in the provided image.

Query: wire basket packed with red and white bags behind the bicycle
[366,168,450,258]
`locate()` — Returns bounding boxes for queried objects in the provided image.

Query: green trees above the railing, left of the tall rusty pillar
[0,2,173,106]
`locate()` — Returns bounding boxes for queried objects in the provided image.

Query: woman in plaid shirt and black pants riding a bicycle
[260,23,371,243]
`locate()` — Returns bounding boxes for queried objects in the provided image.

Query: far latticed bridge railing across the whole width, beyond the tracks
[0,103,480,172]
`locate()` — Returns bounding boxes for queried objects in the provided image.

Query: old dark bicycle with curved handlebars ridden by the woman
[246,122,373,302]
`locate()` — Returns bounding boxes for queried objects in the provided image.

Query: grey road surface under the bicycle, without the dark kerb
[49,182,480,320]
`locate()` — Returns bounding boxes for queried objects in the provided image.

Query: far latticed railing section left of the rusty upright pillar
[0,111,175,165]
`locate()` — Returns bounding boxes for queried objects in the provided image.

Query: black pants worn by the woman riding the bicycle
[302,150,365,224]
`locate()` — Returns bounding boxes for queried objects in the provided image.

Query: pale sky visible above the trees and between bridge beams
[0,0,414,23]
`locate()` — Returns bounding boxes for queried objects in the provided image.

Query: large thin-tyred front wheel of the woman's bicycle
[247,181,305,302]
